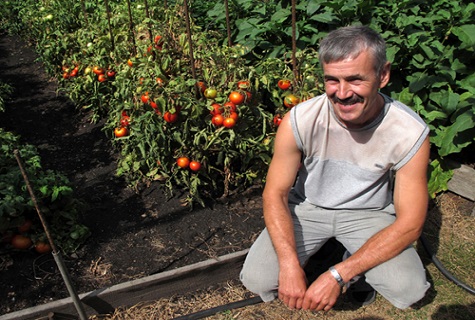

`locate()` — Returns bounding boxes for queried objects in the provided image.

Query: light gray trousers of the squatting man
[240,202,430,309]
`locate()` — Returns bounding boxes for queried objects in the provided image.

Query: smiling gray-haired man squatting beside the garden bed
[241,26,430,311]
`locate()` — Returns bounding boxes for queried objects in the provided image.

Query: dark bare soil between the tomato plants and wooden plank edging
[0,35,264,315]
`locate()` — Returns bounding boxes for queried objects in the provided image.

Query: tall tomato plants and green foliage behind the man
[0,0,475,204]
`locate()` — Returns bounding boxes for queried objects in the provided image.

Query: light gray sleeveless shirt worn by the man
[290,94,429,210]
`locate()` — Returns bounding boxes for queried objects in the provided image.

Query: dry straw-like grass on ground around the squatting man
[92,195,475,320]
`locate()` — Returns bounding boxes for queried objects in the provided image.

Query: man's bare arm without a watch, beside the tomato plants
[263,113,307,308]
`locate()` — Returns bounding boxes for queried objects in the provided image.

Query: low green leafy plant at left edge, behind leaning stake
[0,128,89,253]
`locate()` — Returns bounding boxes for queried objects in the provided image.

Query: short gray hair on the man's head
[319,26,387,75]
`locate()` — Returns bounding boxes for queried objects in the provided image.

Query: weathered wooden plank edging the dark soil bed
[0,250,248,320]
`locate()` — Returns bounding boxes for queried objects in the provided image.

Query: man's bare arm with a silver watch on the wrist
[303,138,430,310]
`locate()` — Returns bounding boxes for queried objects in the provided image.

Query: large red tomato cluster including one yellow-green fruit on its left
[203,81,252,129]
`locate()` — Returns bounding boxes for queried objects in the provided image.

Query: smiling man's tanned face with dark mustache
[323,51,390,128]
